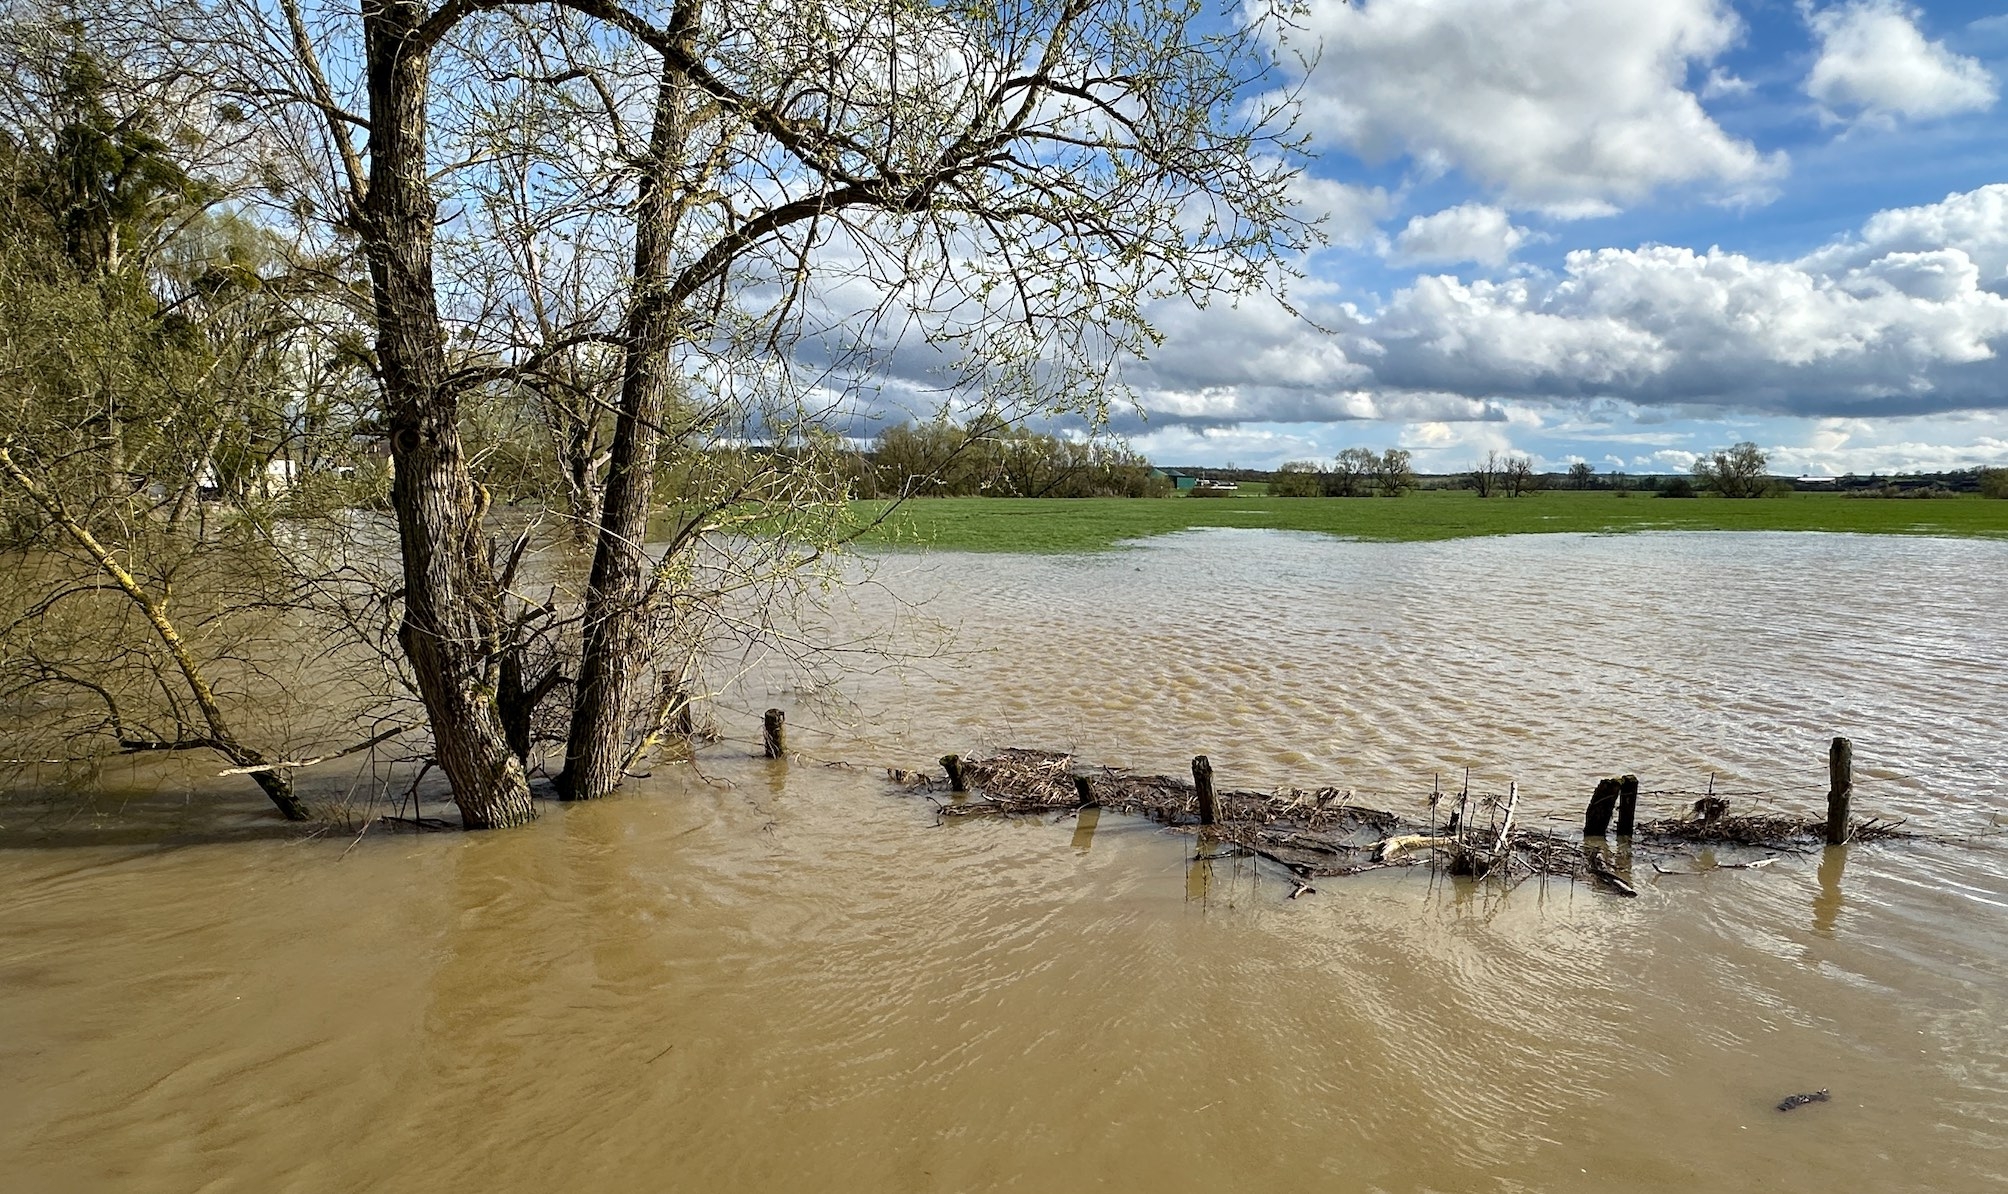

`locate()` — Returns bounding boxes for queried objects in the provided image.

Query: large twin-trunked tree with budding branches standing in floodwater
[145,0,1311,827]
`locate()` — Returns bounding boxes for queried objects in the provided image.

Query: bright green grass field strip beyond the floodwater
[857,490,2008,552]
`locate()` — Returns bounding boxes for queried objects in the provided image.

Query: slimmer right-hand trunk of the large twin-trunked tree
[558,53,685,801]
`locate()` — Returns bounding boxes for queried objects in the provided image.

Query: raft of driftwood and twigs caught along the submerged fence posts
[888,749,1918,895]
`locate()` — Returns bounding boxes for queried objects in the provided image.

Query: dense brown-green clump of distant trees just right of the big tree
[851,417,1171,498]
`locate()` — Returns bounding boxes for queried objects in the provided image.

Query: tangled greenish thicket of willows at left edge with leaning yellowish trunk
[0,23,395,821]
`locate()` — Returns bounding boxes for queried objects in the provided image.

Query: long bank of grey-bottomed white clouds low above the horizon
[1133,185,2008,425]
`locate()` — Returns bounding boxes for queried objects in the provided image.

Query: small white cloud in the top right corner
[1805,0,1996,120]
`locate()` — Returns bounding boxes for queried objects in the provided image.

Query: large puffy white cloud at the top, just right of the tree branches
[1277,0,1783,217]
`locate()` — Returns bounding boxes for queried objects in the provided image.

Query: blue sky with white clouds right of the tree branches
[1116,0,2008,474]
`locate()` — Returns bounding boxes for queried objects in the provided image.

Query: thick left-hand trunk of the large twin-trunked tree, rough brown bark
[359,0,536,829]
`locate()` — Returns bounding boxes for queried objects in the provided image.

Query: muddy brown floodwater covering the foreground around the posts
[0,532,2008,1194]
